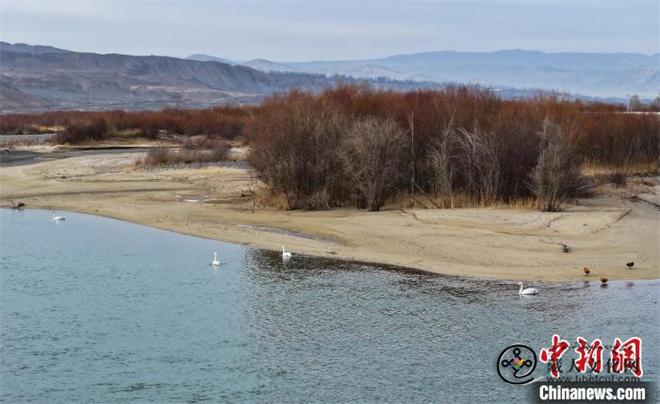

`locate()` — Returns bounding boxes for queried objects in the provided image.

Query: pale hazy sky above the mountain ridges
[0,0,660,61]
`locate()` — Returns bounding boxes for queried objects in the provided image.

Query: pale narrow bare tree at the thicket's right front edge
[531,119,589,212]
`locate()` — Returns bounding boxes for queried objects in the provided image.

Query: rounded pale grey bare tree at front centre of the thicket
[341,118,406,211]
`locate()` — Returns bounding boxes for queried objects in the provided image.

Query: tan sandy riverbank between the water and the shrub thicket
[0,150,660,281]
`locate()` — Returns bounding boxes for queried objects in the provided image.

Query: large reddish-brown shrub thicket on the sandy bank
[250,86,660,210]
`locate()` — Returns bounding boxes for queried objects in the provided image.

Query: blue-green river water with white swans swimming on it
[0,209,660,403]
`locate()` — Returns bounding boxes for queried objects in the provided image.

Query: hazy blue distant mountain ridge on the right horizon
[191,49,660,97]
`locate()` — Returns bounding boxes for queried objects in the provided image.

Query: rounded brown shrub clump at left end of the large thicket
[250,92,348,209]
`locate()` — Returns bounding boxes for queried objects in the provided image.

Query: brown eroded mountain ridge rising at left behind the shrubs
[0,42,438,112]
